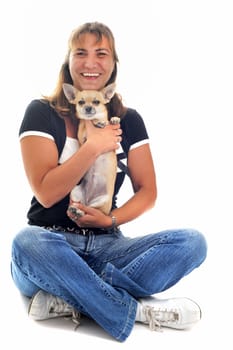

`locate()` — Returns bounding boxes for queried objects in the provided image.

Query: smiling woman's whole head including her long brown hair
[42,22,125,119]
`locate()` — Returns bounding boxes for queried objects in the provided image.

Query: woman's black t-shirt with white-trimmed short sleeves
[19,100,148,228]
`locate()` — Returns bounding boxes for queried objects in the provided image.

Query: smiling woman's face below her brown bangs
[69,33,115,90]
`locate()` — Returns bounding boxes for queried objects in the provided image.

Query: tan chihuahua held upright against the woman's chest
[63,84,120,216]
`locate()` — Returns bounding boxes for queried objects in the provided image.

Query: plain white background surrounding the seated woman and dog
[0,0,233,349]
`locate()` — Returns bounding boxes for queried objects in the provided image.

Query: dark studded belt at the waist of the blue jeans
[43,225,116,236]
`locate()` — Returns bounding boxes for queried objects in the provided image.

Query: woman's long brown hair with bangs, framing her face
[44,22,126,118]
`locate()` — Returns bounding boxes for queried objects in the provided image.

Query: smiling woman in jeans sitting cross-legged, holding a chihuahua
[11,22,207,341]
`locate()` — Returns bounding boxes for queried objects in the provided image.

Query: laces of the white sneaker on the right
[144,306,179,331]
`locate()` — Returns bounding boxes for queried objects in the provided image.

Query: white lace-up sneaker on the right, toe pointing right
[138,297,201,330]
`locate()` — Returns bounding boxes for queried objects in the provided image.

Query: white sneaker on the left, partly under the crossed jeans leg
[28,290,80,325]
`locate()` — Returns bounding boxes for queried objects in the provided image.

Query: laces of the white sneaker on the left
[49,297,81,330]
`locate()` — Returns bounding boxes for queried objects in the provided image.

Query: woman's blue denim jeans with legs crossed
[11,226,207,341]
